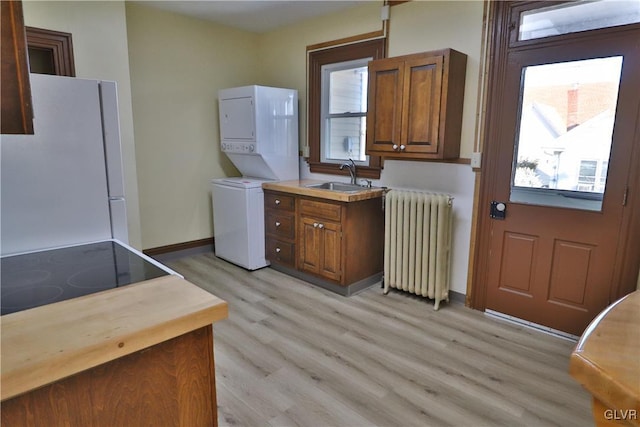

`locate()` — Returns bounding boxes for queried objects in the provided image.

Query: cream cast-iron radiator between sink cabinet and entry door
[384,190,453,310]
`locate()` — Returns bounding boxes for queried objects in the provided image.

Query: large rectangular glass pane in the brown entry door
[510,56,622,211]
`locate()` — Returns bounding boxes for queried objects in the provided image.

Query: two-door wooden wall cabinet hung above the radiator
[367,49,467,159]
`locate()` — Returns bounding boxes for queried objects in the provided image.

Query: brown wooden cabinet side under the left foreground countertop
[1,325,218,427]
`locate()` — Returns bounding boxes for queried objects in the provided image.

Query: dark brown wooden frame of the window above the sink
[307,37,386,179]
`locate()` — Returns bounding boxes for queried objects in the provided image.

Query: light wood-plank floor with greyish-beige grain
[168,254,593,427]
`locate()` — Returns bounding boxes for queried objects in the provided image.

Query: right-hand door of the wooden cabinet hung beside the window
[400,56,443,153]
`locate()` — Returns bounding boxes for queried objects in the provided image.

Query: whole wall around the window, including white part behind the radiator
[260,0,483,294]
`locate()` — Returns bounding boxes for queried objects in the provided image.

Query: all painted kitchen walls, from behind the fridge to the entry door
[25,0,482,278]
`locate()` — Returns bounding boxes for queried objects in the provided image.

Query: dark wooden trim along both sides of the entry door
[467,1,640,311]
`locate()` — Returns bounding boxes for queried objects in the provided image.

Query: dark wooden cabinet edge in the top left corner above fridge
[0,0,33,134]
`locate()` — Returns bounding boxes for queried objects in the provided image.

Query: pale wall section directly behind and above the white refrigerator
[23,1,142,249]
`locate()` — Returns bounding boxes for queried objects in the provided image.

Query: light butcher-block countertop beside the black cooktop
[0,276,228,400]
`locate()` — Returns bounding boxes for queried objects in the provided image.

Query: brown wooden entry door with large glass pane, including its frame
[476,2,640,335]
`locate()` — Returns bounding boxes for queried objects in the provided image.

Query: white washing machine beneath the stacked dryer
[211,177,269,270]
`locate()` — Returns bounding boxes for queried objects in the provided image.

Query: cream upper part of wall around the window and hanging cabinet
[259,1,483,158]
